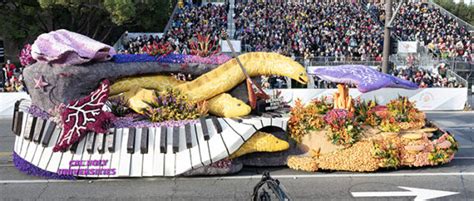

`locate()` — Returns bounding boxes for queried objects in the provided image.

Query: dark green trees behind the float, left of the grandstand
[0,0,176,48]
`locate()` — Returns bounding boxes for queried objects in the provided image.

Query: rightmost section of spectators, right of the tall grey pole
[380,2,474,61]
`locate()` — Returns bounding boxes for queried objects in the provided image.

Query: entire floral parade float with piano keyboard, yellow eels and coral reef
[12,30,457,179]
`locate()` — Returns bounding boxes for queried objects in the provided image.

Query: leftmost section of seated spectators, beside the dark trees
[119,4,228,54]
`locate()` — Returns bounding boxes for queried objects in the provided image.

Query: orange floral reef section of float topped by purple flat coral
[288,65,457,172]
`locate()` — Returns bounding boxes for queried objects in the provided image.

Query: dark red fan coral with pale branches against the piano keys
[53,80,113,152]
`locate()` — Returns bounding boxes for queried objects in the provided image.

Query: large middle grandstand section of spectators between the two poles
[234,2,383,60]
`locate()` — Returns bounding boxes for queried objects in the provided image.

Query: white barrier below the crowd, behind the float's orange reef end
[270,88,467,111]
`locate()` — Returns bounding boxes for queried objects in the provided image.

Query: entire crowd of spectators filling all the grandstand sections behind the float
[121,0,474,61]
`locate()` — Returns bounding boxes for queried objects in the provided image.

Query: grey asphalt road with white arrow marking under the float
[0,112,474,200]
